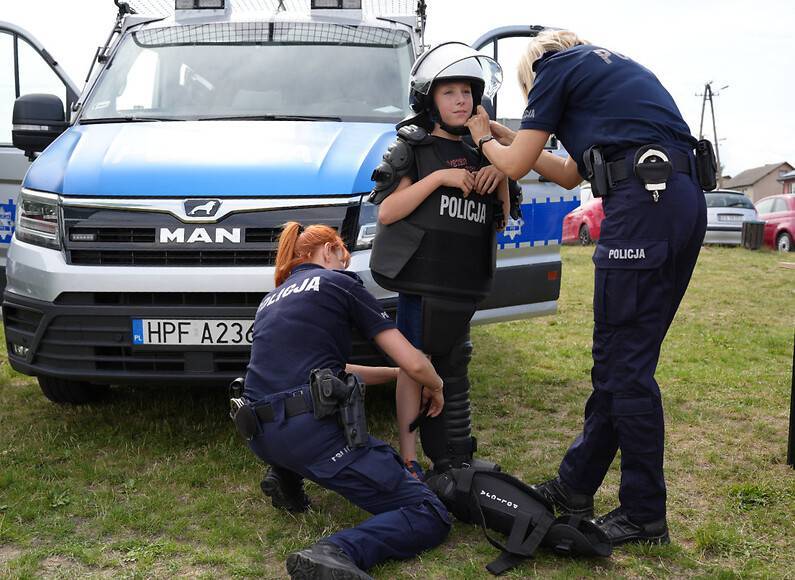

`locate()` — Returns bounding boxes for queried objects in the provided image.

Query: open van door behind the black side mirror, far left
[0,21,78,290]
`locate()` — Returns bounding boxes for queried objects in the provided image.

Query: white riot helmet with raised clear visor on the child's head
[411,42,502,98]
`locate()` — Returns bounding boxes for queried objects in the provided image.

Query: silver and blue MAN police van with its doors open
[0,0,577,403]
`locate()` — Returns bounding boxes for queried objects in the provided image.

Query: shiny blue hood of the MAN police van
[23,121,395,197]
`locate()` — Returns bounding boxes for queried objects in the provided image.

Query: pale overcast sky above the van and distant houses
[0,0,795,175]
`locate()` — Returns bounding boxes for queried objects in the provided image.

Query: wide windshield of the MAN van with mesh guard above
[80,22,413,123]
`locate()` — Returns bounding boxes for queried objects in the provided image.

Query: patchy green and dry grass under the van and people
[0,248,795,579]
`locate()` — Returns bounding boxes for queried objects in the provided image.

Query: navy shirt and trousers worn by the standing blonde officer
[521,45,706,523]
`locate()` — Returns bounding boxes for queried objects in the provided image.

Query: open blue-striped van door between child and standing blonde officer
[472,26,579,316]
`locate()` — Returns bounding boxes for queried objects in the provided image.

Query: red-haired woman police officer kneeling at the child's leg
[232,222,450,579]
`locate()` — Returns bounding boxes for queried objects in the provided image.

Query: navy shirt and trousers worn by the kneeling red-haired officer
[244,264,450,570]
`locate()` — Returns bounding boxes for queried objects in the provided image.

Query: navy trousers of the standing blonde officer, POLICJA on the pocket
[559,161,706,523]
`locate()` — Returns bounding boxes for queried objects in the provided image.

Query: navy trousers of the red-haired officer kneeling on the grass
[249,394,450,570]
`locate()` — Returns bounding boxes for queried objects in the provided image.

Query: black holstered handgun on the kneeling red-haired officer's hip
[309,369,369,448]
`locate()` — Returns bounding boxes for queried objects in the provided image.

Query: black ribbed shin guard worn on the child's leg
[420,332,499,476]
